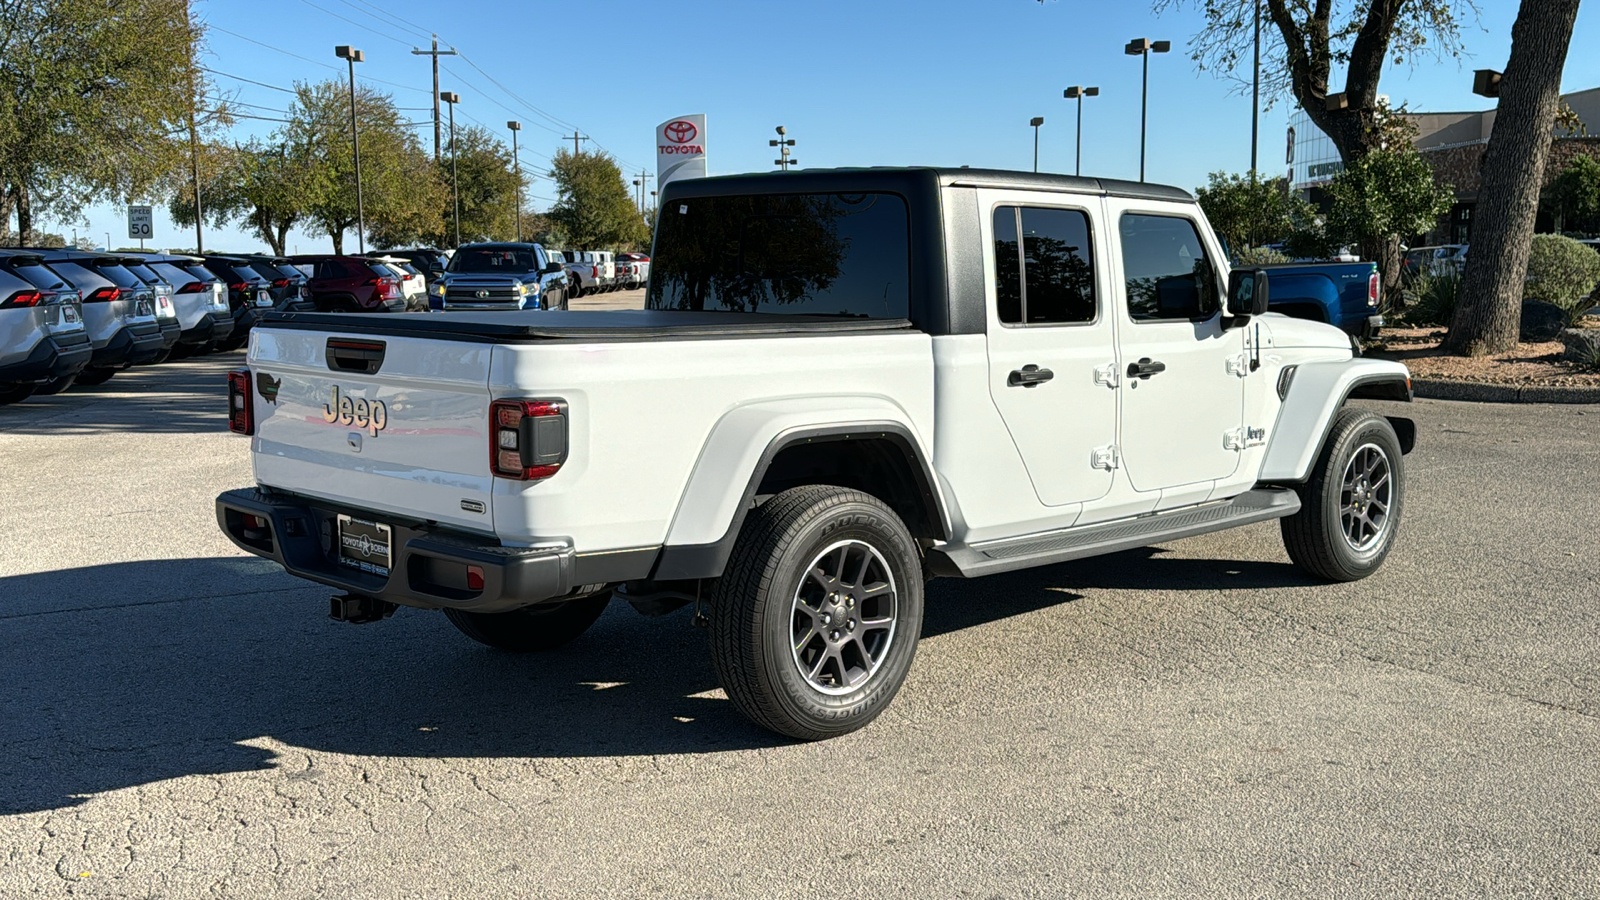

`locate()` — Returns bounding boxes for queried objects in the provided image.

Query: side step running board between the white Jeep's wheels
[928,488,1299,578]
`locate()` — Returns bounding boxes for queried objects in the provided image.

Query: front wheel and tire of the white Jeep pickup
[1280,408,1405,581]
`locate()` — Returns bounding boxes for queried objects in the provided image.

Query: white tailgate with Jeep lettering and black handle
[250,327,493,533]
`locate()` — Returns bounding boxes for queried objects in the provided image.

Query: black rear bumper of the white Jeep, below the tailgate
[216,488,658,612]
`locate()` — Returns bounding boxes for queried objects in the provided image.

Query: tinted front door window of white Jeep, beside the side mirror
[1120,215,1219,322]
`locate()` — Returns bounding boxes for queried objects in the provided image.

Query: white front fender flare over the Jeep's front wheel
[1258,359,1416,484]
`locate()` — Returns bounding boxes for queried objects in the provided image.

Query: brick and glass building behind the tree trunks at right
[1286,88,1600,243]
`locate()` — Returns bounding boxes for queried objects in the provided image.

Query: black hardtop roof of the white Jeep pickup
[667,167,1194,203]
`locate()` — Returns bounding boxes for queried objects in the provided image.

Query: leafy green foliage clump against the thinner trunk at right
[1326,146,1456,257]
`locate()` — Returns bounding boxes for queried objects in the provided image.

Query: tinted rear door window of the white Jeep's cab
[995,207,1098,325]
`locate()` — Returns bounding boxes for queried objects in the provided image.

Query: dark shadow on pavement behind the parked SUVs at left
[0,352,245,436]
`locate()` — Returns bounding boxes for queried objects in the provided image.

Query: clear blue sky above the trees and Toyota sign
[65,0,1600,253]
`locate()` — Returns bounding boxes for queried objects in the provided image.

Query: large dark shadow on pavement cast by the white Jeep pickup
[0,549,1309,815]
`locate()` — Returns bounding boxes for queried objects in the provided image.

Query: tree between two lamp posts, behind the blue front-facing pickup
[427,125,528,247]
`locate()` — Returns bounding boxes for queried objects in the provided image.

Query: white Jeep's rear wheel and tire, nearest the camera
[710,485,923,740]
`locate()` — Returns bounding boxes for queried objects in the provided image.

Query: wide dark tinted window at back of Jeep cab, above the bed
[645,194,910,319]
